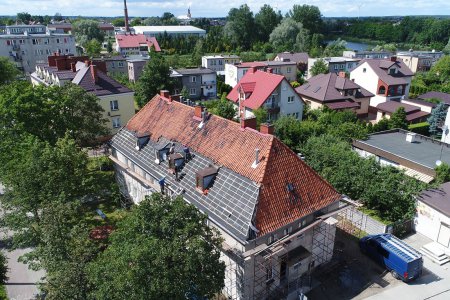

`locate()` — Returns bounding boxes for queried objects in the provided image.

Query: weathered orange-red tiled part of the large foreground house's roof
[126,95,340,236]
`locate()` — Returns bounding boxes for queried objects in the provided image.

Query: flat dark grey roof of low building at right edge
[358,130,450,169]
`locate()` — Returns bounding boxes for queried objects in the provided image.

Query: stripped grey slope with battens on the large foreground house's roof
[111,128,259,241]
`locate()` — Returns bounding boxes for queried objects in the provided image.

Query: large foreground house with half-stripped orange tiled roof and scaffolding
[110,91,342,299]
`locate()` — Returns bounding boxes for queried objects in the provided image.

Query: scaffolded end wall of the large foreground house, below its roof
[222,200,362,299]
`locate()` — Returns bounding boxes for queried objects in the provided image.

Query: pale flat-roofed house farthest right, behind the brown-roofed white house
[397,50,444,73]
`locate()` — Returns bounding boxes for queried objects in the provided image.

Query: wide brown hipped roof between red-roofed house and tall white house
[295,73,374,102]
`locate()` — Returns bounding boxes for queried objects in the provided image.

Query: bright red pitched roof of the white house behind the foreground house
[227,70,284,109]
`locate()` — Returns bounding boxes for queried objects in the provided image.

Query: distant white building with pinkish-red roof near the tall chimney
[116,33,161,56]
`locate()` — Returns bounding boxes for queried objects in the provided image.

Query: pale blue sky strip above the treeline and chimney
[0,0,450,18]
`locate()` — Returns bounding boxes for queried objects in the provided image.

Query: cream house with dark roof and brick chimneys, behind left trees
[31,55,134,133]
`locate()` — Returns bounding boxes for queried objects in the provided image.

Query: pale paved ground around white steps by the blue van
[367,234,450,300]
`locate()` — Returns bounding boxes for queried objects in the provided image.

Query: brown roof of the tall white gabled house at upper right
[354,59,414,85]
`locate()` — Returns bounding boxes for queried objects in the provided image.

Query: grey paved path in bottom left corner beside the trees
[0,183,44,300]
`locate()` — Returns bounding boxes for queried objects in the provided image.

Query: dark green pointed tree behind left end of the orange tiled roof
[135,51,174,107]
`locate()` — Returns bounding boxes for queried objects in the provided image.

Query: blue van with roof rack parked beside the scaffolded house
[359,233,423,282]
